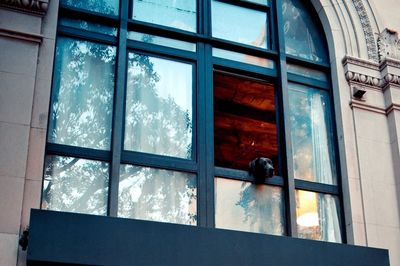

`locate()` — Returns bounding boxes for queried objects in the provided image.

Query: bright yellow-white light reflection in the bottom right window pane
[296,190,319,227]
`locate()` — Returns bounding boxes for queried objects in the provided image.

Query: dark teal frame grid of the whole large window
[42,0,346,243]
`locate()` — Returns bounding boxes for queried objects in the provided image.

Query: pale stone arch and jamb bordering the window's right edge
[304,0,386,245]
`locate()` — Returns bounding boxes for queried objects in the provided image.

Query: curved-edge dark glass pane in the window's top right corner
[282,0,328,63]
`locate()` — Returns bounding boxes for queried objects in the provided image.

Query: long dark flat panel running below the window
[27,210,389,266]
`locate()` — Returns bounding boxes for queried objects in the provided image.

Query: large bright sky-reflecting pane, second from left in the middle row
[124,53,193,159]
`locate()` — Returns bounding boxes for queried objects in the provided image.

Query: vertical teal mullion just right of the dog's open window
[274,0,297,237]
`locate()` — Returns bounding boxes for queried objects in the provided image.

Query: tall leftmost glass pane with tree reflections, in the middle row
[48,37,116,150]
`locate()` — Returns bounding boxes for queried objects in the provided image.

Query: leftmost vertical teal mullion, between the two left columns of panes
[108,0,129,216]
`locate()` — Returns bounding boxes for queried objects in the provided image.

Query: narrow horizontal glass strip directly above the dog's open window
[212,48,275,68]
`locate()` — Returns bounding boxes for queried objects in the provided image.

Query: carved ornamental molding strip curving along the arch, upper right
[353,0,379,62]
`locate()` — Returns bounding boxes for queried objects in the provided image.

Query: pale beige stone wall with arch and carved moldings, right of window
[313,0,400,266]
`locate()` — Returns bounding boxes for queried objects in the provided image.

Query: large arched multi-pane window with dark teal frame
[42,0,345,242]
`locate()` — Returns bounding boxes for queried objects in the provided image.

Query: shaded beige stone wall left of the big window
[0,1,58,266]
